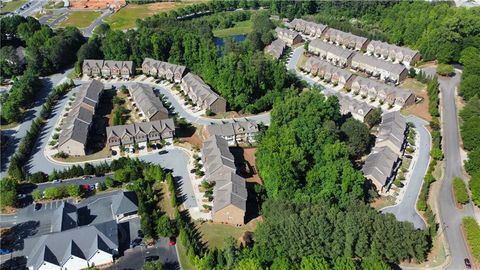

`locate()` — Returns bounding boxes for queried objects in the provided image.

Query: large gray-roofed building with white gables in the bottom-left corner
[24,220,118,269]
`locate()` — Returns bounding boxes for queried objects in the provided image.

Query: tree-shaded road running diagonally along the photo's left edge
[0,69,71,177]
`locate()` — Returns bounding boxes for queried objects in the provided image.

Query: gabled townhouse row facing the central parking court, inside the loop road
[107,119,175,152]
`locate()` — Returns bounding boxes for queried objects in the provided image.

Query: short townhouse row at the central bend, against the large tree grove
[205,121,258,146]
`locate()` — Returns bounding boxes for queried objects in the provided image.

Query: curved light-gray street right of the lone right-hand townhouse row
[381,116,432,230]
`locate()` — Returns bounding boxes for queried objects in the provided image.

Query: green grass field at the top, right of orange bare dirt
[105,2,191,30]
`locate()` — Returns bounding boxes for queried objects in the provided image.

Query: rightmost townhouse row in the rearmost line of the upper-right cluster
[367,40,421,67]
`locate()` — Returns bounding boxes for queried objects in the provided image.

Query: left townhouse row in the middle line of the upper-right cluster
[308,39,354,68]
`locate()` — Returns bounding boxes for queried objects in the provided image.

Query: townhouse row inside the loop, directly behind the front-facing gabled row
[128,83,168,121]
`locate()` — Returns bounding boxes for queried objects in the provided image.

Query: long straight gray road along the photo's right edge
[424,68,474,269]
